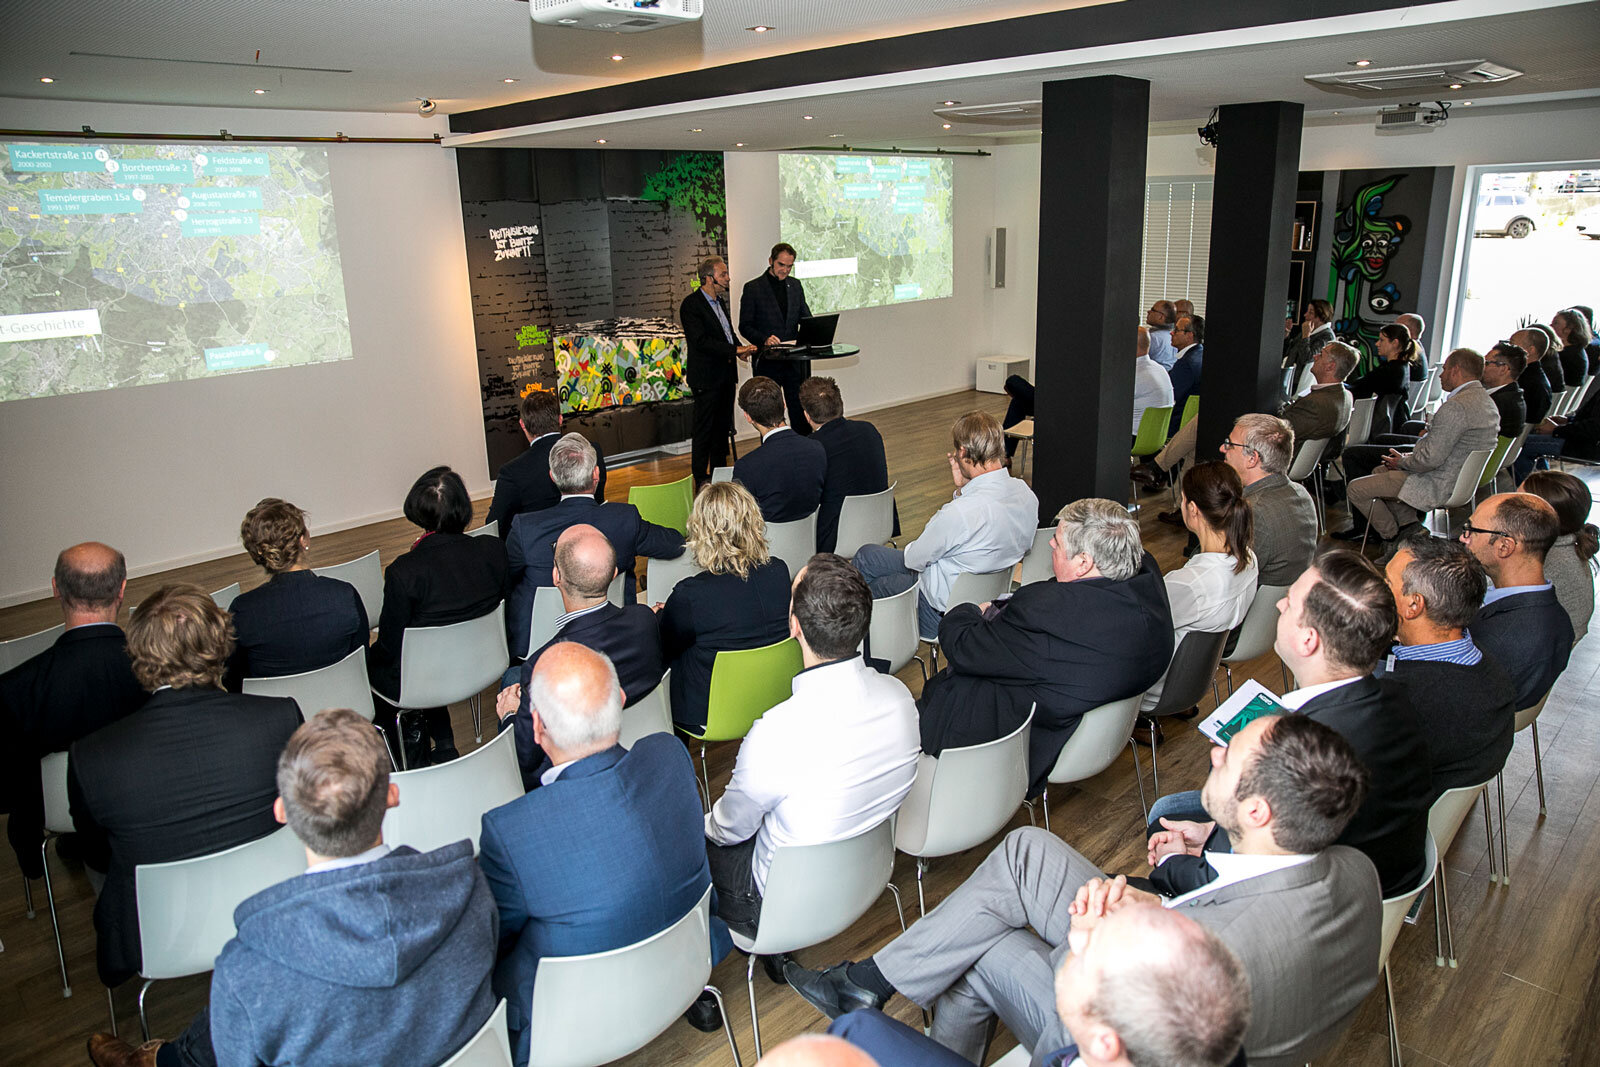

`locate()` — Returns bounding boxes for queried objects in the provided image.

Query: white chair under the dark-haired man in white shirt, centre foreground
[732,819,906,1059]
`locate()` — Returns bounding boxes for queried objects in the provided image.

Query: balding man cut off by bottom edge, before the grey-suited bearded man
[829,908,1251,1067]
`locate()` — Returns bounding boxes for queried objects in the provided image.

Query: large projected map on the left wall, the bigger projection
[0,144,350,400]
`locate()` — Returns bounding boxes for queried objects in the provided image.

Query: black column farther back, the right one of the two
[1195,101,1305,459]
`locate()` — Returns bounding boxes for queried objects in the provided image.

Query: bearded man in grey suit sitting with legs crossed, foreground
[784,715,1382,1067]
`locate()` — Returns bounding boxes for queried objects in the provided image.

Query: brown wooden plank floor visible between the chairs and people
[0,392,1600,1067]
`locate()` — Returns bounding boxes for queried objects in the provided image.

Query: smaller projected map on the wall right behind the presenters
[778,154,955,312]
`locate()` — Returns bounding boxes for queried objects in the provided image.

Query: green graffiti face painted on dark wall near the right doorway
[1328,174,1411,373]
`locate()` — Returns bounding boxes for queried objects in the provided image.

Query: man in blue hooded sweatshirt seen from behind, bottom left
[90,710,496,1067]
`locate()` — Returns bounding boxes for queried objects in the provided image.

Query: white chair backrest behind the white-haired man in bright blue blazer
[528,886,713,1067]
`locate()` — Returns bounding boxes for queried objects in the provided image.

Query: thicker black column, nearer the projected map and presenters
[1034,77,1150,522]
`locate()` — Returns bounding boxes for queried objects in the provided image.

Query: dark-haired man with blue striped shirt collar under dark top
[1384,536,1517,798]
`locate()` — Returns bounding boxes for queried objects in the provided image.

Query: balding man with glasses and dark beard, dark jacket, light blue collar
[1461,493,1573,709]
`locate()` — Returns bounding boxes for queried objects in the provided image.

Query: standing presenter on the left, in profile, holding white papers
[678,259,755,488]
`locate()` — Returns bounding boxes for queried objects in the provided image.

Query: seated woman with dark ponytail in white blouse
[1141,461,1256,712]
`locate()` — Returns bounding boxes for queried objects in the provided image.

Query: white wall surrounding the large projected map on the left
[0,99,488,603]
